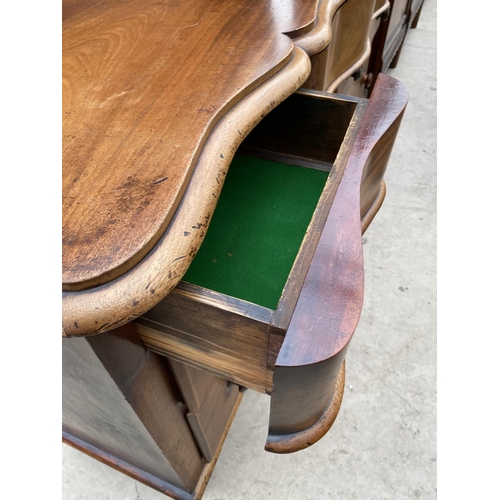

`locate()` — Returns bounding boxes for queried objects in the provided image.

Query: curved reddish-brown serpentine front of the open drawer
[269,74,408,453]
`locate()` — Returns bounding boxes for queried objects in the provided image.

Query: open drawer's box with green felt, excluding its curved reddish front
[135,90,367,394]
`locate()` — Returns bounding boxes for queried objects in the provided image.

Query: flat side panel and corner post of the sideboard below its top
[62,325,205,492]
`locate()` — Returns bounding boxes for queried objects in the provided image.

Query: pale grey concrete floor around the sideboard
[63,0,437,500]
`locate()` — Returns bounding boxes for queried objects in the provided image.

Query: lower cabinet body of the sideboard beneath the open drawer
[62,324,241,500]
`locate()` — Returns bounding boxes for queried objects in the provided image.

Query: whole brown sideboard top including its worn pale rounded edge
[62,0,364,336]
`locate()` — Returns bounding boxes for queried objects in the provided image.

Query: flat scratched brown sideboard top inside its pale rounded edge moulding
[63,0,316,290]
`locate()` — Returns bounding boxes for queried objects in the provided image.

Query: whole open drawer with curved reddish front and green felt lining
[135,75,408,453]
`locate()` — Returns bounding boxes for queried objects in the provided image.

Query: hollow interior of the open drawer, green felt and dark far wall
[184,92,356,310]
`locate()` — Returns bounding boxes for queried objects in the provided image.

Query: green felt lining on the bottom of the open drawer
[184,154,328,309]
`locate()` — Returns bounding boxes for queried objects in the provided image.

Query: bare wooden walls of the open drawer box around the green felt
[136,91,366,394]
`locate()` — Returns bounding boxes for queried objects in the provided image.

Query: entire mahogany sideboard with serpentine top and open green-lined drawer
[62,0,408,499]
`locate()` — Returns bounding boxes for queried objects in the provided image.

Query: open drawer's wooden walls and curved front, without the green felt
[132,75,408,453]
